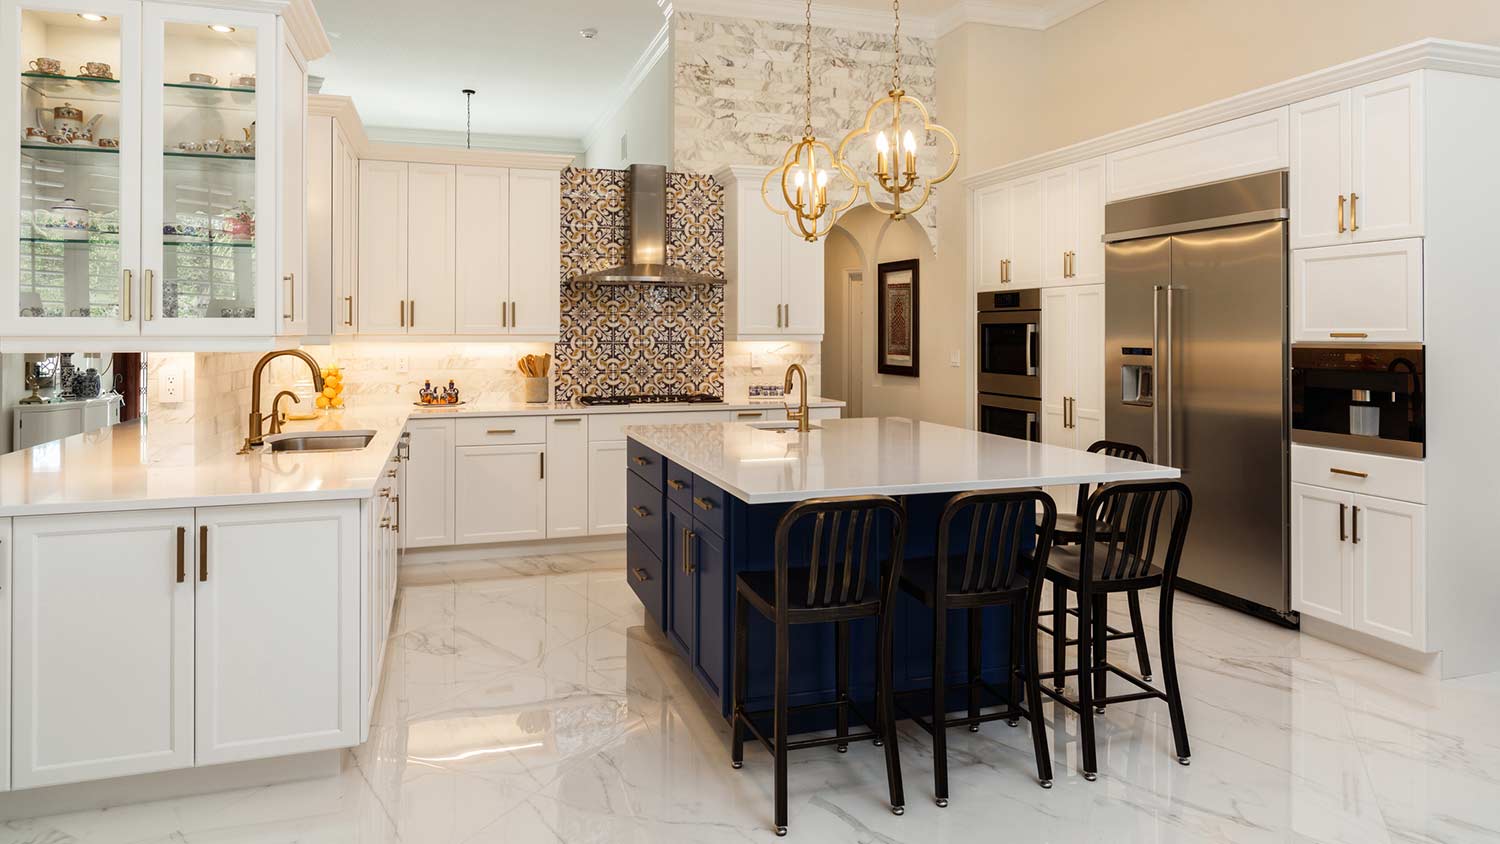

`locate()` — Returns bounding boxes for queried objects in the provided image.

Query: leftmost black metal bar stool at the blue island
[731,495,906,835]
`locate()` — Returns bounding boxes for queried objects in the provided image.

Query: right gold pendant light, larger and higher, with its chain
[839,0,959,220]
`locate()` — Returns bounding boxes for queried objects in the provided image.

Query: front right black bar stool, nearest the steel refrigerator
[1043,481,1193,781]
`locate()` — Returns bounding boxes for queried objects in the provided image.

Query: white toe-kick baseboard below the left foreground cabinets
[0,750,345,820]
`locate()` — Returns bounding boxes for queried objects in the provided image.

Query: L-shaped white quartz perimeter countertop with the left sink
[0,399,843,517]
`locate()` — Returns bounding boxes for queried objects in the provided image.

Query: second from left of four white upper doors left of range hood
[407,163,458,334]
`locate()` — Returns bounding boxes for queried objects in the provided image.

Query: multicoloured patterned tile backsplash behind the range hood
[552,168,725,402]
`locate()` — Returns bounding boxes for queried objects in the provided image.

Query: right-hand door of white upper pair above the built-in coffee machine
[1352,72,1424,241]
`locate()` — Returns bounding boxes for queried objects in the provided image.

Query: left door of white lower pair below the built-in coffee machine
[1292,484,1355,627]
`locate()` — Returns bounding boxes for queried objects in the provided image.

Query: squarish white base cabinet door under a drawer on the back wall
[455,444,548,544]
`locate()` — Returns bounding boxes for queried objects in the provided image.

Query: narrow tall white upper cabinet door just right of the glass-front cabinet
[276,24,309,336]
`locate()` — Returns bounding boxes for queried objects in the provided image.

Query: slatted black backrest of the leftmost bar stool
[776,495,906,610]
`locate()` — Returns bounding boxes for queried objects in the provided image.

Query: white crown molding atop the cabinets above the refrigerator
[963,39,1500,190]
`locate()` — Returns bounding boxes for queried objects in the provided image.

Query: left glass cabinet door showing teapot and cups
[0,0,143,337]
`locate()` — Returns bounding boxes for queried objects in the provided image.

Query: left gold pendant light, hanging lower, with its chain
[761,0,860,243]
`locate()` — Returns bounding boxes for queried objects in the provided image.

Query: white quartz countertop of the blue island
[626,417,1181,504]
